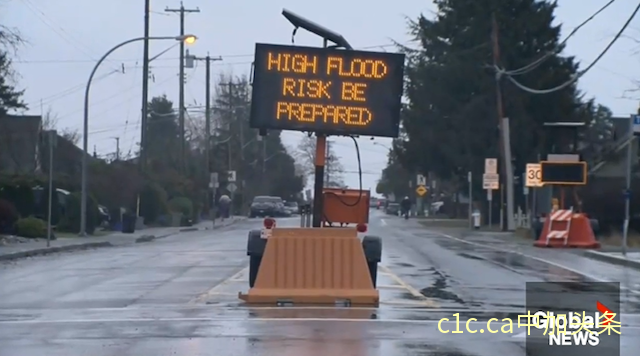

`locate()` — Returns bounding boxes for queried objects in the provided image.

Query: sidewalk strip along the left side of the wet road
[0,217,246,261]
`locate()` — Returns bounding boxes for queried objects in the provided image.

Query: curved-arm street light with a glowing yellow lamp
[80,35,197,236]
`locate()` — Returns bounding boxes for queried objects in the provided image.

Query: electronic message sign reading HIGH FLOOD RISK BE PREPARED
[250,43,404,137]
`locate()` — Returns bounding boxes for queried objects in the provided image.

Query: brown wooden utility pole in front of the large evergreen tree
[491,14,513,231]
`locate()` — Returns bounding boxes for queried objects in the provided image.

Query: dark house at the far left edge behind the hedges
[0,115,42,174]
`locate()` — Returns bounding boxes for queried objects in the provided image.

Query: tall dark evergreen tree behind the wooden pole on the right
[399,0,604,193]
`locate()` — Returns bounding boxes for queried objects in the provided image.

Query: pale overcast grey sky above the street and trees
[5,0,640,195]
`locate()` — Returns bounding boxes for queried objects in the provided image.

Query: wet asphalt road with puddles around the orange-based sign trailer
[0,212,640,356]
